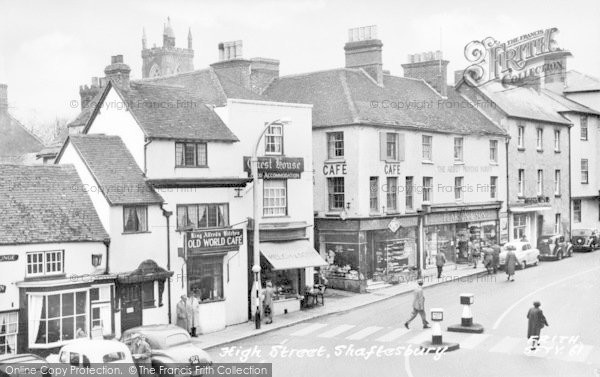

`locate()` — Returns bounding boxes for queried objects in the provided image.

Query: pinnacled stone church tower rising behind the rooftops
[142,18,194,78]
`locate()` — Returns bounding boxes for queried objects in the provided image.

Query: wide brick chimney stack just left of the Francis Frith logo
[402,50,449,97]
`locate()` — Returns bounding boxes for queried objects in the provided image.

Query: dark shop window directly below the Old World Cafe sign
[187,256,224,301]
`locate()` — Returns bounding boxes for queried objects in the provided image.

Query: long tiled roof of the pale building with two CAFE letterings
[264,68,505,135]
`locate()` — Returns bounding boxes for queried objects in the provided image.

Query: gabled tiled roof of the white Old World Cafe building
[80,81,238,142]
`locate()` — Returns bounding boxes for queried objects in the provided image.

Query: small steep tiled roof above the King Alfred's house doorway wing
[68,134,163,205]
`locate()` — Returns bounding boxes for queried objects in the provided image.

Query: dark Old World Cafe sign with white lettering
[185,229,244,254]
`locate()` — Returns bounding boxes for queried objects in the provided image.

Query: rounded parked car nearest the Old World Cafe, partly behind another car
[121,325,212,376]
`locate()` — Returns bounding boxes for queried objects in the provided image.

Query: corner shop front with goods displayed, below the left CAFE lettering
[315,215,418,292]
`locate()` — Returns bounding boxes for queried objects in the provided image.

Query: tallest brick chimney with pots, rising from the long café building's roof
[344,26,383,85]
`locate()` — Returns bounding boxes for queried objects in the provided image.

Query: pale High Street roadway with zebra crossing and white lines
[208,251,600,377]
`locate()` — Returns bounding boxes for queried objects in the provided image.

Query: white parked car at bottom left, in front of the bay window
[46,339,139,377]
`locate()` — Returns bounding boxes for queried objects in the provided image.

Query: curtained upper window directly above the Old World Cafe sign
[177,203,229,230]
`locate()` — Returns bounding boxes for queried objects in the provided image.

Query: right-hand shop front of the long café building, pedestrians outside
[423,202,501,267]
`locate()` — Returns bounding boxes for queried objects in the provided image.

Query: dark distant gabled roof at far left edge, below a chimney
[0,111,44,161]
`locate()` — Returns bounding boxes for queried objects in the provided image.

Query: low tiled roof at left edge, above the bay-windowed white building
[0,165,108,244]
